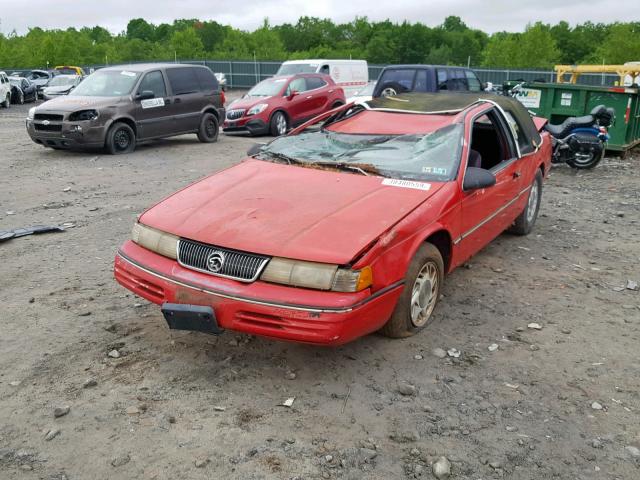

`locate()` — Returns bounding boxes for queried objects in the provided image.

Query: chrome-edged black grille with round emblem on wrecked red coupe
[178,238,269,282]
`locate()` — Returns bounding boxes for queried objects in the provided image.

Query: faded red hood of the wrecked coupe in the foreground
[140,159,443,264]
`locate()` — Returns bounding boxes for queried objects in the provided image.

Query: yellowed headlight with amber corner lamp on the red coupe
[260,257,373,292]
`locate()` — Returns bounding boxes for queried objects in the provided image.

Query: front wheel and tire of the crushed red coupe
[380,243,444,338]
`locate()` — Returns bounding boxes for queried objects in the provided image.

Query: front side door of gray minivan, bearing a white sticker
[134,70,175,138]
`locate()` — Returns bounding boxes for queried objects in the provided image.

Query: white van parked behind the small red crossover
[276,60,369,97]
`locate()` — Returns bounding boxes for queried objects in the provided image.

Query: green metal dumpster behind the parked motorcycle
[504,81,640,153]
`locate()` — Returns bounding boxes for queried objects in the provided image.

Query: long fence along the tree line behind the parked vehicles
[5,60,618,88]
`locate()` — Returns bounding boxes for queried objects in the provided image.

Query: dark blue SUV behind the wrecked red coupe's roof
[373,65,482,98]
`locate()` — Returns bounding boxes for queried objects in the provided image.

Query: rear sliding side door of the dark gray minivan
[166,67,203,133]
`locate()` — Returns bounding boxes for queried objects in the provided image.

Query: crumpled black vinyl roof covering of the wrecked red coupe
[367,92,542,153]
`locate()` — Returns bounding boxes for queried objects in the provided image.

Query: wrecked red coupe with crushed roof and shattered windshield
[115,93,551,345]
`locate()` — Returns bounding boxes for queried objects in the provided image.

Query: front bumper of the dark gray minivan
[26,119,106,149]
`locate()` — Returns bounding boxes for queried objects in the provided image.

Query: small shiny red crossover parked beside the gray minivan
[222,73,345,137]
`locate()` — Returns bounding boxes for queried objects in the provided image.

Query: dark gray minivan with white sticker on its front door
[26,63,225,154]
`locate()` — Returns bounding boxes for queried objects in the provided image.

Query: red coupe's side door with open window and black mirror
[456,108,526,261]
